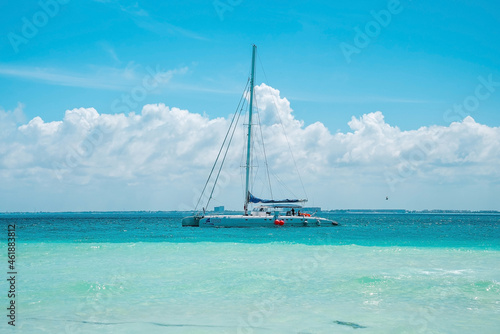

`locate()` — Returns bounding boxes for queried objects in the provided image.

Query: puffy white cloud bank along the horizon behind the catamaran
[0,84,500,211]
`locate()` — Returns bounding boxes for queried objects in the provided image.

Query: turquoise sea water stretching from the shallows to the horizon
[0,213,500,333]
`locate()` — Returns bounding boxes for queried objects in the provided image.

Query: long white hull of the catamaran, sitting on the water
[182,215,338,228]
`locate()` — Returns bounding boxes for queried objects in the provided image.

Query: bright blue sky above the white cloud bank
[0,0,500,210]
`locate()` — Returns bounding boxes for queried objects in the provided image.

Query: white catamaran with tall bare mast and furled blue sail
[182,45,338,227]
